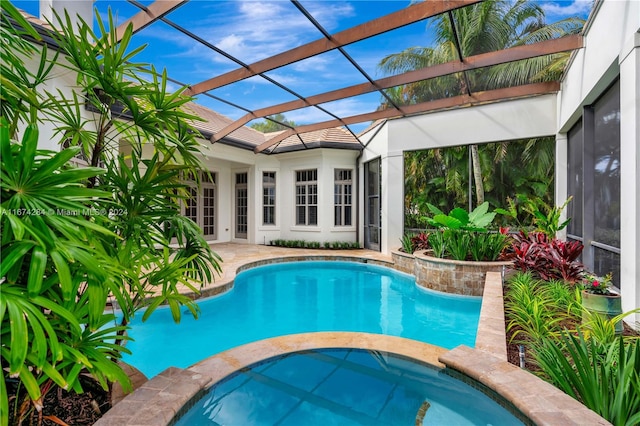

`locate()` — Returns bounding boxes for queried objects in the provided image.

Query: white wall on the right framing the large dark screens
[556,0,640,323]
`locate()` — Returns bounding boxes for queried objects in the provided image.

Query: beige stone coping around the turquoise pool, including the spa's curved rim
[95,251,610,426]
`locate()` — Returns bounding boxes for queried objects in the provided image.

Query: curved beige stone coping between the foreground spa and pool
[95,332,610,426]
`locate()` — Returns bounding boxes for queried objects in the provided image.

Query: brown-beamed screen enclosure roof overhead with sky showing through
[16,0,588,154]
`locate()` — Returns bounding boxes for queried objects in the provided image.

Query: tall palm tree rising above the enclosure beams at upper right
[379,0,584,205]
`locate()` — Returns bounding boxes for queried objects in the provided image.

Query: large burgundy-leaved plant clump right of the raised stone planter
[512,232,584,283]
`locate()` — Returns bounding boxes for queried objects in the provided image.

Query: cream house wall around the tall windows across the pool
[201,140,358,245]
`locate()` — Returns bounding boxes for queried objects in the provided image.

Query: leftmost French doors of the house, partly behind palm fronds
[184,172,216,239]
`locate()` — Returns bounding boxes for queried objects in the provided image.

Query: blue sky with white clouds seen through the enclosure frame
[13,0,592,131]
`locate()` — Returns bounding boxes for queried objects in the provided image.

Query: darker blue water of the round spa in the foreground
[176,349,523,426]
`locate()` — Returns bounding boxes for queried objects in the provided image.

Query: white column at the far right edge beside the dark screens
[620,33,640,330]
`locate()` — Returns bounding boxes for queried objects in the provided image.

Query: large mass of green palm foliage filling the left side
[0,2,220,425]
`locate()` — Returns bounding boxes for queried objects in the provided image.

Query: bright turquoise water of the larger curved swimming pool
[124,261,481,377]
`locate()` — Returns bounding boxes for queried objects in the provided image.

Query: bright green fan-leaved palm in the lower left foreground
[0,117,130,424]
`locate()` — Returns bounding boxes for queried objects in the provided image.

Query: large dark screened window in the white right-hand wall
[567,81,622,285]
